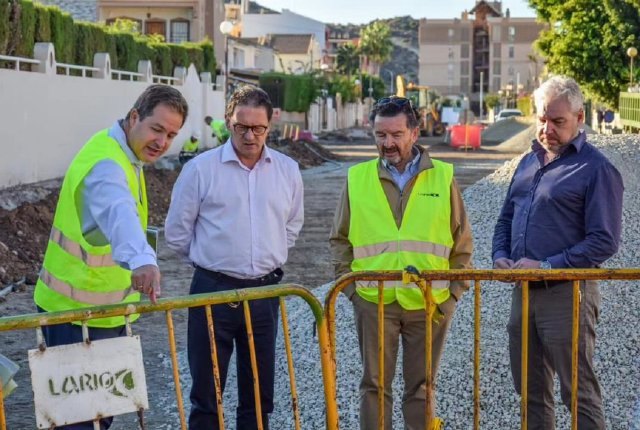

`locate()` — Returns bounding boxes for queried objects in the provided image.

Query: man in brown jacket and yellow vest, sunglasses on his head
[330,97,473,429]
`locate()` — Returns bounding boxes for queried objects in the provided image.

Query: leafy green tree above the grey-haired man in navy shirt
[529,0,640,107]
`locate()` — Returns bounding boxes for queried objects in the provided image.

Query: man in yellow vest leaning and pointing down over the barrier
[34,85,188,430]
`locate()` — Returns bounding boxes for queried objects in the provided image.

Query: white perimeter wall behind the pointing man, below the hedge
[0,66,224,189]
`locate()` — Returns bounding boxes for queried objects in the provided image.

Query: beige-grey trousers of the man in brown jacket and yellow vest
[351,293,455,430]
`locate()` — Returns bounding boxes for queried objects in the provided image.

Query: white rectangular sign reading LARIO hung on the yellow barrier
[29,336,149,429]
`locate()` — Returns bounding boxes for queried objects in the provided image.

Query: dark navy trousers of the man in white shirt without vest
[187,268,283,430]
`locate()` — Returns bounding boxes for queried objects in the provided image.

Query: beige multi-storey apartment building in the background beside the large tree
[419,0,543,104]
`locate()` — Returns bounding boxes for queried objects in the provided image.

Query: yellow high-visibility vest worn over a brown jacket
[348,159,453,310]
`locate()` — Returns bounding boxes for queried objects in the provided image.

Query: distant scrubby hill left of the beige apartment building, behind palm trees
[326,15,419,89]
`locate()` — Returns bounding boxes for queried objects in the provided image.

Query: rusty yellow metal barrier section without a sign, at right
[324,269,640,430]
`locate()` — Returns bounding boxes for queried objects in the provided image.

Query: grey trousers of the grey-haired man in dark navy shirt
[507,282,605,430]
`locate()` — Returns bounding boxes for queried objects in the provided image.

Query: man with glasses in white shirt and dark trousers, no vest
[165,86,304,430]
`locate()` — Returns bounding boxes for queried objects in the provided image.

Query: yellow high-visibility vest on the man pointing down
[34,130,148,327]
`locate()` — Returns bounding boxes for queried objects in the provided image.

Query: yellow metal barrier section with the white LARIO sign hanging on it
[0,284,338,430]
